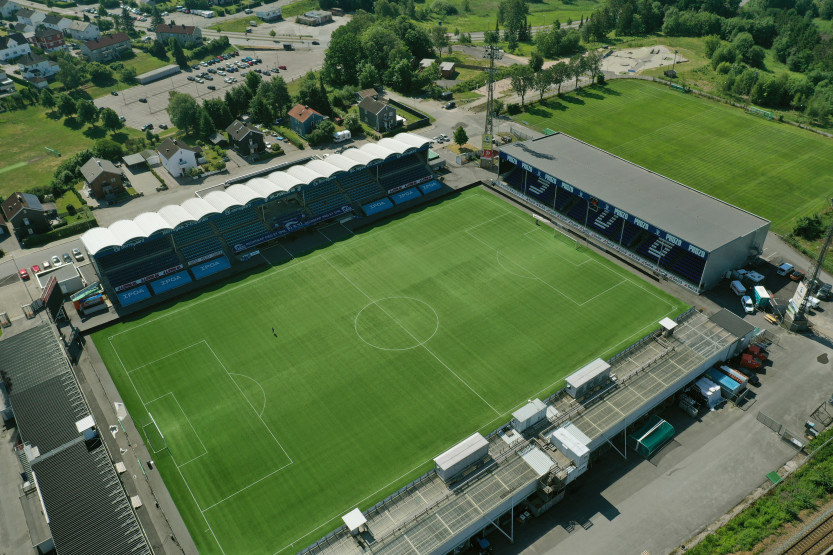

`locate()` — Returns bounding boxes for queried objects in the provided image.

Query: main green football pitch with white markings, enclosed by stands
[93,189,686,554]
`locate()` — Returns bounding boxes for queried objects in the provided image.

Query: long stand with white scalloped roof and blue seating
[81,133,442,307]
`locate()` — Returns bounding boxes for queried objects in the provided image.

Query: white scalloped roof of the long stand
[81,133,430,256]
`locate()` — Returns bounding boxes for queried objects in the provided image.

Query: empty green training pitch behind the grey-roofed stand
[515,79,833,234]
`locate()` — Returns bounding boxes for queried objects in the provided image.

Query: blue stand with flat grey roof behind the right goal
[490,133,769,293]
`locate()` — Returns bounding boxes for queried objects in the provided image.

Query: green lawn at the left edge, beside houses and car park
[0,106,142,198]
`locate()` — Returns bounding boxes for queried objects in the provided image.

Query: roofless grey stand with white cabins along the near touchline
[301,309,756,555]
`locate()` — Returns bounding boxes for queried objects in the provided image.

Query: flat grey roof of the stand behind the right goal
[501,133,769,251]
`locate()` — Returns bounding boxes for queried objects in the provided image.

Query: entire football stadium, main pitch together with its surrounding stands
[4,133,769,554]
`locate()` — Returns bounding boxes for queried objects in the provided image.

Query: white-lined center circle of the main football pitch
[355,297,440,351]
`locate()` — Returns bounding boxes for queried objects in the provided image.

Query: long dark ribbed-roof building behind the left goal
[0,323,151,555]
